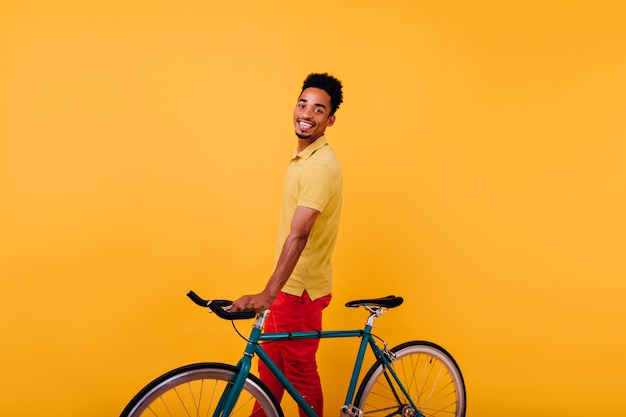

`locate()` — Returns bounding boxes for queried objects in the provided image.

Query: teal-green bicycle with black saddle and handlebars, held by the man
[121,291,466,417]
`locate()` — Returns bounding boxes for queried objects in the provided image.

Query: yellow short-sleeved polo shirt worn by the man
[276,136,343,300]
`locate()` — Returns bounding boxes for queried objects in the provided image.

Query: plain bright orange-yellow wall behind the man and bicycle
[0,0,626,417]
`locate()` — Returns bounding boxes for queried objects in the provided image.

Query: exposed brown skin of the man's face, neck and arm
[231,87,335,313]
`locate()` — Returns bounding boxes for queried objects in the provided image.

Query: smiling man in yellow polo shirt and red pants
[233,73,343,416]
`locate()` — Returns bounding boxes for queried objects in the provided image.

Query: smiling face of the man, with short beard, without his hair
[293,87,335,142]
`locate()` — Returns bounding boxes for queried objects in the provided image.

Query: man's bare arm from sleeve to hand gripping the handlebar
[232,206,320,313]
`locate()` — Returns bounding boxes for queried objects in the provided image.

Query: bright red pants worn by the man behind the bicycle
[255,291,331,417]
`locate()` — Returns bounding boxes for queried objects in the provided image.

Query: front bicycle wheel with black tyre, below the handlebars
[121,363,283,417]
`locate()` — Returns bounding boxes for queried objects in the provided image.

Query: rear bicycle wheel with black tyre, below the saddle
[354,341,466,417]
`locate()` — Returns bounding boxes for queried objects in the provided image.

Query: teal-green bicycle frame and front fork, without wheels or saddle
[214,313,424,417]
